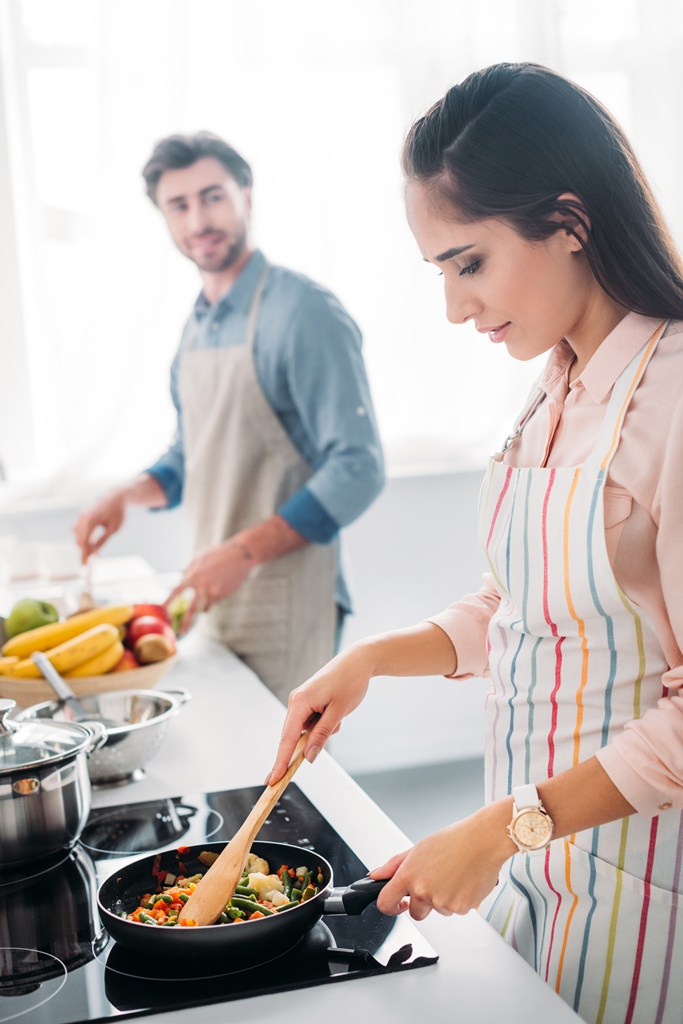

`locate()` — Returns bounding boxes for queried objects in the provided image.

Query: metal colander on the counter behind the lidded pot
[17,689,190,787]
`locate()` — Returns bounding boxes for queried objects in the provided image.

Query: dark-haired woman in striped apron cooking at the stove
[270,65,683,1024]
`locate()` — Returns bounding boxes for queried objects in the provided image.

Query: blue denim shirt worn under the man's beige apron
[147,251,384,610]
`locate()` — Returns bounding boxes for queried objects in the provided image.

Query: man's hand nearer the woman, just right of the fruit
[166,540,256,634]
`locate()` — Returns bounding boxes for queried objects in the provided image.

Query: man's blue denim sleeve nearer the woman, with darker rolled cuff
[278,290,384,544]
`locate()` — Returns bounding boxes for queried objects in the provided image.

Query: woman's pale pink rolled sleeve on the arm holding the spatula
[426,572,501,679]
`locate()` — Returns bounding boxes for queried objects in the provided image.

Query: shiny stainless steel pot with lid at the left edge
[0,699,106,869]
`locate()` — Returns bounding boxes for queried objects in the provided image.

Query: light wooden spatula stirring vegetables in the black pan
[178,732,307,925]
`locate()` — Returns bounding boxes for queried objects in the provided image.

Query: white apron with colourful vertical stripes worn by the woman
[479,325,683,1024]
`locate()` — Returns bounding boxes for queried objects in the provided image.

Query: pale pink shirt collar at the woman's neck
[541,312,661,404]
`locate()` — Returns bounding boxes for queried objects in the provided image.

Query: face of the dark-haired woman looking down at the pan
[405,181,596,360]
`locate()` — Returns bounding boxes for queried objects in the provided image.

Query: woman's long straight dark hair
[402,63,683,319]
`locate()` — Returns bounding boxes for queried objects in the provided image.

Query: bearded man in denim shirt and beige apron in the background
[75,132,384,701]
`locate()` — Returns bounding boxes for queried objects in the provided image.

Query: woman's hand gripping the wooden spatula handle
[266,643,374,785]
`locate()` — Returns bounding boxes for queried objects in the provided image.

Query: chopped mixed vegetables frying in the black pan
[119,847,325,928]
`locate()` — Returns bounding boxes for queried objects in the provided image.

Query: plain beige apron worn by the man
[178,266,337,703]
